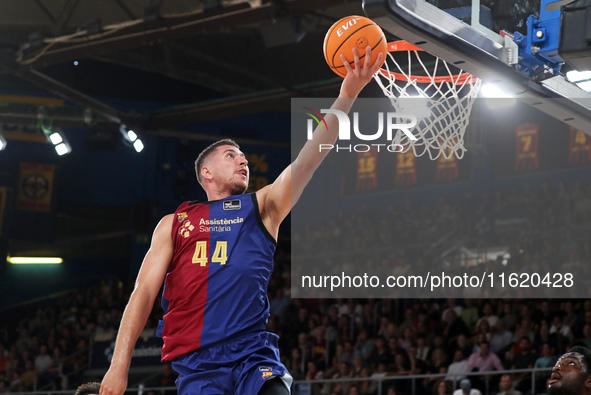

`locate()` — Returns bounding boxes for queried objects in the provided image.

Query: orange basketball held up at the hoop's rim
[324,15,388,77]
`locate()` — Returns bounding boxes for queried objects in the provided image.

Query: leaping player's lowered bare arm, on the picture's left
[100,214,174,395]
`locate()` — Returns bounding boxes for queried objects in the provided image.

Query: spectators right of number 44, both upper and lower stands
[276,182,591,394]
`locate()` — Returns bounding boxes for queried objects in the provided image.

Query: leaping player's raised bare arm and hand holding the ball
[257,47,383,238]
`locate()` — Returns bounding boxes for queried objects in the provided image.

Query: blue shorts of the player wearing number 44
[172,332,293,395]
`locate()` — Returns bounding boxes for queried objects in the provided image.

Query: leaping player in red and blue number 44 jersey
[100,47,382,395]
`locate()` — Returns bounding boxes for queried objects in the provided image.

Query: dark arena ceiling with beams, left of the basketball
[0,0,370,141]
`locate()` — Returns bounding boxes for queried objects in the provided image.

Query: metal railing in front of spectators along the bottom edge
[6,368,551,395]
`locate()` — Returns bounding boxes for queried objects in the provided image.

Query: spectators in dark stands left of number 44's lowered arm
[0,281,140,393]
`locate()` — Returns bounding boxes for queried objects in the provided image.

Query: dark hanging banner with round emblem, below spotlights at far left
[16,162,55,211]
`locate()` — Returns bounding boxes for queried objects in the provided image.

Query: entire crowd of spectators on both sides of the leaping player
[0,183,591,395]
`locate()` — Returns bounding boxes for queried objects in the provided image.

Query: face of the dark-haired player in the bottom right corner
[548,353,591,395]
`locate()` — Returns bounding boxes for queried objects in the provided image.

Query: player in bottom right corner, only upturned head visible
[548,346,591,395]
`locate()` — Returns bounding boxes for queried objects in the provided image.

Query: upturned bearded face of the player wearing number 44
[212,145,250,195]
